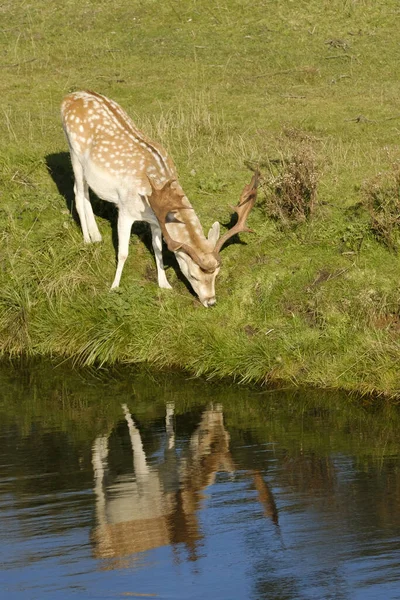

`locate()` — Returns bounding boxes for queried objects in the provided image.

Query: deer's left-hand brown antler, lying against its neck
[148,177,218,272]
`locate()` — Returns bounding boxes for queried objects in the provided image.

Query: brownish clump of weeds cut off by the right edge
[362,162,400,252]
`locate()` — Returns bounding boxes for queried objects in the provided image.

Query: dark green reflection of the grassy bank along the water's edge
[0,359,399,454]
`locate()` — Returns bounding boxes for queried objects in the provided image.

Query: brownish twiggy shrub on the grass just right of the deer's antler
[263,146,318,225]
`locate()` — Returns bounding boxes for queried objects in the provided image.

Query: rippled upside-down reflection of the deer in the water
[92,404,278,569]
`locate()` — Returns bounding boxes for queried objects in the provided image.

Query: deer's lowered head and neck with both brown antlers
[148,172,259,307]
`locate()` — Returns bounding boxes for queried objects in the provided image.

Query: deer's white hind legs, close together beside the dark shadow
[71,150,101,244]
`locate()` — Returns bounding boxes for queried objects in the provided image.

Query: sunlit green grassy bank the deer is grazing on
[0,0,400,396]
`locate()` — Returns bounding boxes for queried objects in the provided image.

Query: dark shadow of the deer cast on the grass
[45,152,196,296]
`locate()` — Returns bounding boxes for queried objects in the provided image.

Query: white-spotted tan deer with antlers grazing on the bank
[61,91,258,307]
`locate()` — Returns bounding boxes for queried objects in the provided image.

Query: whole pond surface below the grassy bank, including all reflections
[0,365,400,600]
